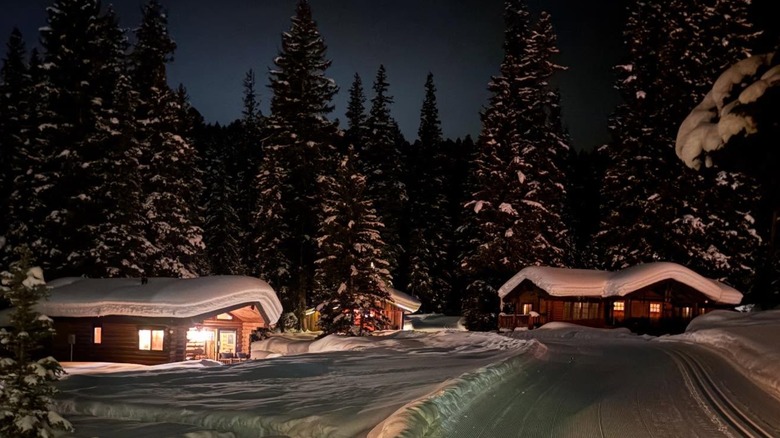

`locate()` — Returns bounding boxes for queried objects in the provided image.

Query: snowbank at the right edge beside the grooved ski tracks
[660,310,780,396]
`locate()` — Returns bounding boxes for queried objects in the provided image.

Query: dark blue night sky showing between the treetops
[0,0,624,149]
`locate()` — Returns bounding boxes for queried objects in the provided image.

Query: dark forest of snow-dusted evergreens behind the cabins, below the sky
[0,0,780,332]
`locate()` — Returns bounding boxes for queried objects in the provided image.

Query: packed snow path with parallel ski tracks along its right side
[435,339,780,438]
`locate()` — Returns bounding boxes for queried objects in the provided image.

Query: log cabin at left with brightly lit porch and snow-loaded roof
[10,276,282,365]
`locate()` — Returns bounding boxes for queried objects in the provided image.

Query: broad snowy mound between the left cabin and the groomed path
[56,331,538,438]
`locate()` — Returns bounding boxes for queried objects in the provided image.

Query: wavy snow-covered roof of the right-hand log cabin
[498,262,742,304]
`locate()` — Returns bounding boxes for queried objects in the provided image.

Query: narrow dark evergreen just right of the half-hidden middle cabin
[407,73,453,313]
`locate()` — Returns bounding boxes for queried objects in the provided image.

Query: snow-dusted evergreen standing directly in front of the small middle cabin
[315,146,391,335]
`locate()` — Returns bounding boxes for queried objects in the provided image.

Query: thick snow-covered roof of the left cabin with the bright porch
[36,275,282,324]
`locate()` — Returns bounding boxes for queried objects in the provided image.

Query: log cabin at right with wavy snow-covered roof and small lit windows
[498,262,742,334]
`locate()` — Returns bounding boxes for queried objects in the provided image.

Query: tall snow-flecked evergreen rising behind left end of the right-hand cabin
[462,0,571,329]
